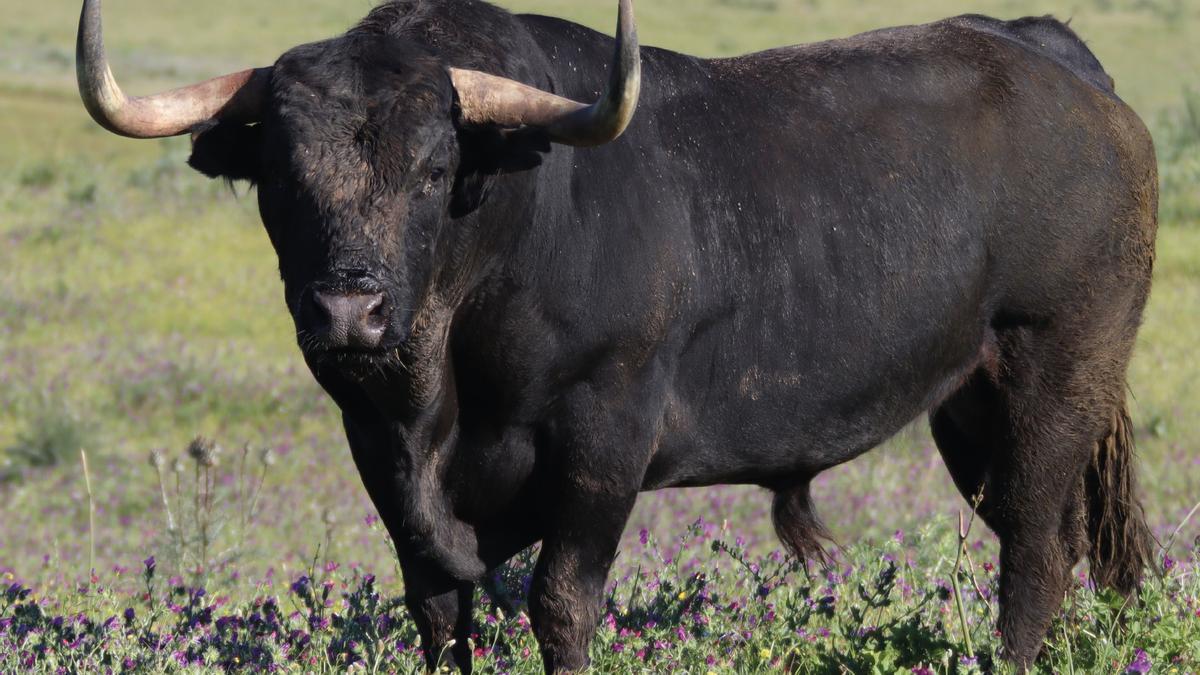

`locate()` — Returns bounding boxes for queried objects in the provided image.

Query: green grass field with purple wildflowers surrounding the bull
[0,0,1200,673]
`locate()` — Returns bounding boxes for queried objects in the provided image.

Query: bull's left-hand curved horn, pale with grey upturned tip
[76,0,270,138]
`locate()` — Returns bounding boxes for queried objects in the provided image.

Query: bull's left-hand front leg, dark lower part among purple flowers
[400,554,475,674]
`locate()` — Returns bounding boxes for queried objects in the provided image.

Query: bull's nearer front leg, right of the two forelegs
[529,388,655,673]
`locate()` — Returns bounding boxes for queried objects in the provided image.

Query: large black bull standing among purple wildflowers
[77,0,1157,671]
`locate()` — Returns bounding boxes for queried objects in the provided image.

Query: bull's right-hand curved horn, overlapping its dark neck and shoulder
[450,0,642,145]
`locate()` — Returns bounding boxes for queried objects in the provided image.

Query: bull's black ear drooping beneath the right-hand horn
[450,127,550,217]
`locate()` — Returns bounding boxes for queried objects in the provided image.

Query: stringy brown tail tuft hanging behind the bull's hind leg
[1085,404,1153,595]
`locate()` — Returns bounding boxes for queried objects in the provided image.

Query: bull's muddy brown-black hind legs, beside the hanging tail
[931,317,1142,667]
